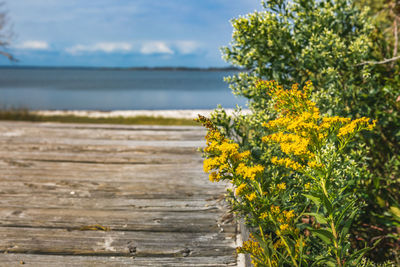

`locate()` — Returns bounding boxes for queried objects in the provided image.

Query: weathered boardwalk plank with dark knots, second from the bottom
[0,227,235,257]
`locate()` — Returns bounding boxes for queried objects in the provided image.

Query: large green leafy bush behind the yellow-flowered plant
[216,0,400,260]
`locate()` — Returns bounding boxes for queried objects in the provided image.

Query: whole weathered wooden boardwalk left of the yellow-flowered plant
[0,122,237,266]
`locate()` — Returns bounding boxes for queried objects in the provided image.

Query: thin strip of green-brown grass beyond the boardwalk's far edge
[0,110,199,126]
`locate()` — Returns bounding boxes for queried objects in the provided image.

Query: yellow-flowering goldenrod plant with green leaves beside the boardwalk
[199,81,382,266]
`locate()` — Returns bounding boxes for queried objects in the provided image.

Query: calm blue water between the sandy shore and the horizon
[0,67,246,111]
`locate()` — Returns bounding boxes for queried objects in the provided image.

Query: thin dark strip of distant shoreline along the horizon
[0,66,246,72]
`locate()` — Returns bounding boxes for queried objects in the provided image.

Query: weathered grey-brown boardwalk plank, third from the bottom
[0,207,235,232]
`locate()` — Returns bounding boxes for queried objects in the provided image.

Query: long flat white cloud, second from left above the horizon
[66,42,133,54]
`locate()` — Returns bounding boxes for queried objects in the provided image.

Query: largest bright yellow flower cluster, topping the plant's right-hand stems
[259,81,376,173]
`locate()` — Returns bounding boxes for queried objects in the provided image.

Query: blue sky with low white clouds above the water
[0,0,261,67]
